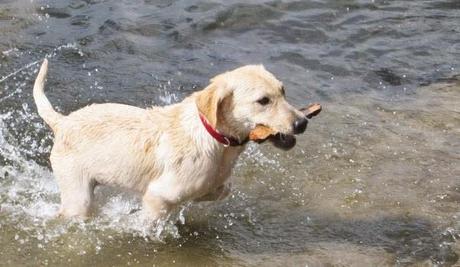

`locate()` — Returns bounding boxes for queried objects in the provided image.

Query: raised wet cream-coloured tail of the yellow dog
[34,58,63,131]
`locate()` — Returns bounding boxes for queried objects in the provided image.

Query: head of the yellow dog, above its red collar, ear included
[196,65,307,148]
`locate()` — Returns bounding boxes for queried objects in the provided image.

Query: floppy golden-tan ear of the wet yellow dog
[195,77,231,127]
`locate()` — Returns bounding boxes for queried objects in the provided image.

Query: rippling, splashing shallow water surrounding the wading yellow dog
[0,0,460,266]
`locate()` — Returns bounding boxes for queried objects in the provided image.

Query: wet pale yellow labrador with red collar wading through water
[33,59,307,220]
